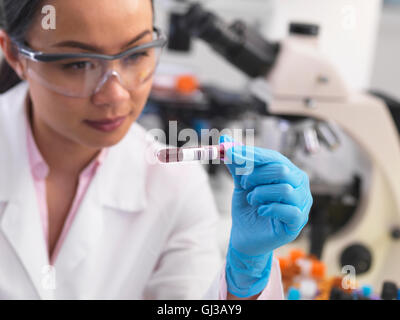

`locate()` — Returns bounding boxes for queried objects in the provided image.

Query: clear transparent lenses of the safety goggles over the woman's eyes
[23,43,162,97]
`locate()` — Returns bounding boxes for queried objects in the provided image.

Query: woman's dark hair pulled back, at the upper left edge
[0,0,154,94]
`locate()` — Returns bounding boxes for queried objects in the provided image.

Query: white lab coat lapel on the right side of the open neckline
[55,135,147,292]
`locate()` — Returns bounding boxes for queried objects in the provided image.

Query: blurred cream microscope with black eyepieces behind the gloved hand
[163,3,400,285]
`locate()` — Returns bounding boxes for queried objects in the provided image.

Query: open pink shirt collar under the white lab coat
[26,107,108,265]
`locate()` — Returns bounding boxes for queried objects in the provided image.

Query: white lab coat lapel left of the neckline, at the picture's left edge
[0,84,53,299]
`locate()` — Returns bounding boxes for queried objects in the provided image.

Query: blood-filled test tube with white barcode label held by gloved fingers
[157,142,235,163]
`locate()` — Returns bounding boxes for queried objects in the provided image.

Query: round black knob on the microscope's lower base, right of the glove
[340,244,372,274]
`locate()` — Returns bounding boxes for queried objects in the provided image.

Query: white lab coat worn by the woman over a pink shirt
[0,83,282,299]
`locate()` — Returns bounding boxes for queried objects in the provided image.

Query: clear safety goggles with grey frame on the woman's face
[13,28,167,98]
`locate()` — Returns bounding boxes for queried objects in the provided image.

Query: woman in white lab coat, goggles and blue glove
[0,0,312,299]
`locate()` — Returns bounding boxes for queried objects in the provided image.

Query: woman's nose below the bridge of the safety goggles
[92,71,130,105]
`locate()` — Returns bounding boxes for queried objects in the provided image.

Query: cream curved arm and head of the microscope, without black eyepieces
[251,30,400,285]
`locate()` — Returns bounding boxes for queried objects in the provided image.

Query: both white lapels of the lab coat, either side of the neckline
[0,83,147,299]
